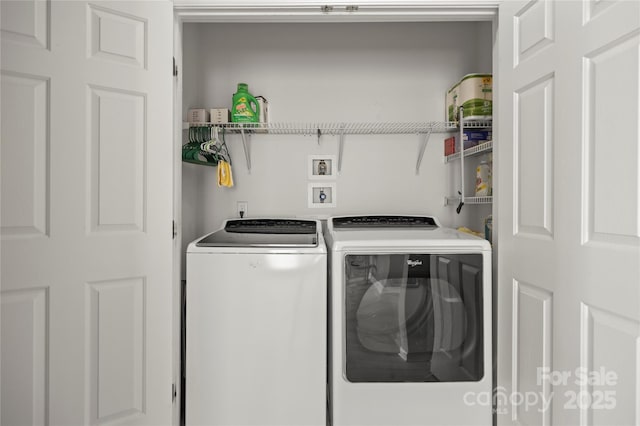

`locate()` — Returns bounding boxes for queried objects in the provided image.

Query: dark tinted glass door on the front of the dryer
[344,254,484,382]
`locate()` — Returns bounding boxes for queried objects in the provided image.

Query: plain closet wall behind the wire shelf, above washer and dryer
[183,22,492,272]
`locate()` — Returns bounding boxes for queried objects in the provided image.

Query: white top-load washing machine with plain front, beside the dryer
[185,219,327,426]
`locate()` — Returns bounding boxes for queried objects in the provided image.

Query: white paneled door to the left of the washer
[0,0,173,425]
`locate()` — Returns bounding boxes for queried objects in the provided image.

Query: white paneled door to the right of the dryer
[496,0,640,426]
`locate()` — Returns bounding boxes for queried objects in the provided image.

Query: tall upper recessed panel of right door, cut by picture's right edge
[582,30,640,246]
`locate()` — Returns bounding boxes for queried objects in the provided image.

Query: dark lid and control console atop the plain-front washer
[196,219,318,247]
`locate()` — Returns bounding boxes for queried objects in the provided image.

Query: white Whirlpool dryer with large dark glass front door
[325,215,492,426]
